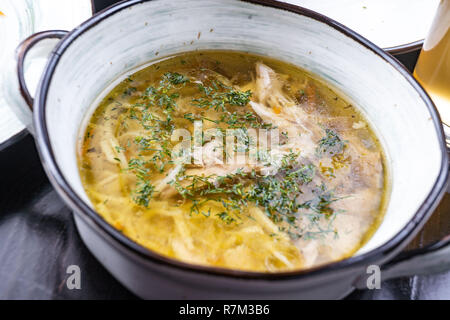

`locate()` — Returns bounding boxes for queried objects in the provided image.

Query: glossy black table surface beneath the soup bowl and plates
[0,0,450,299]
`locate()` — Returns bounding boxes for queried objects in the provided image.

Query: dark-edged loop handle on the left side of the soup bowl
[16,30,69,110]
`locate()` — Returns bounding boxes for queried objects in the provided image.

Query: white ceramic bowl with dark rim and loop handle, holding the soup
[14,0,448,298]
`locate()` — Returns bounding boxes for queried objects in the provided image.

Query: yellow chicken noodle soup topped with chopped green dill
[78,51,388,272]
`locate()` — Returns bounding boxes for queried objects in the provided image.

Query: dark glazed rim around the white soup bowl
[33,0,449,281]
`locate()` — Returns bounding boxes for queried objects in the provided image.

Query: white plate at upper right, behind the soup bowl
[283,0,439,53]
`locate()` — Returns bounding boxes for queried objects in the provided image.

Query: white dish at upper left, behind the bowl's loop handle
[0,0,92,150]
